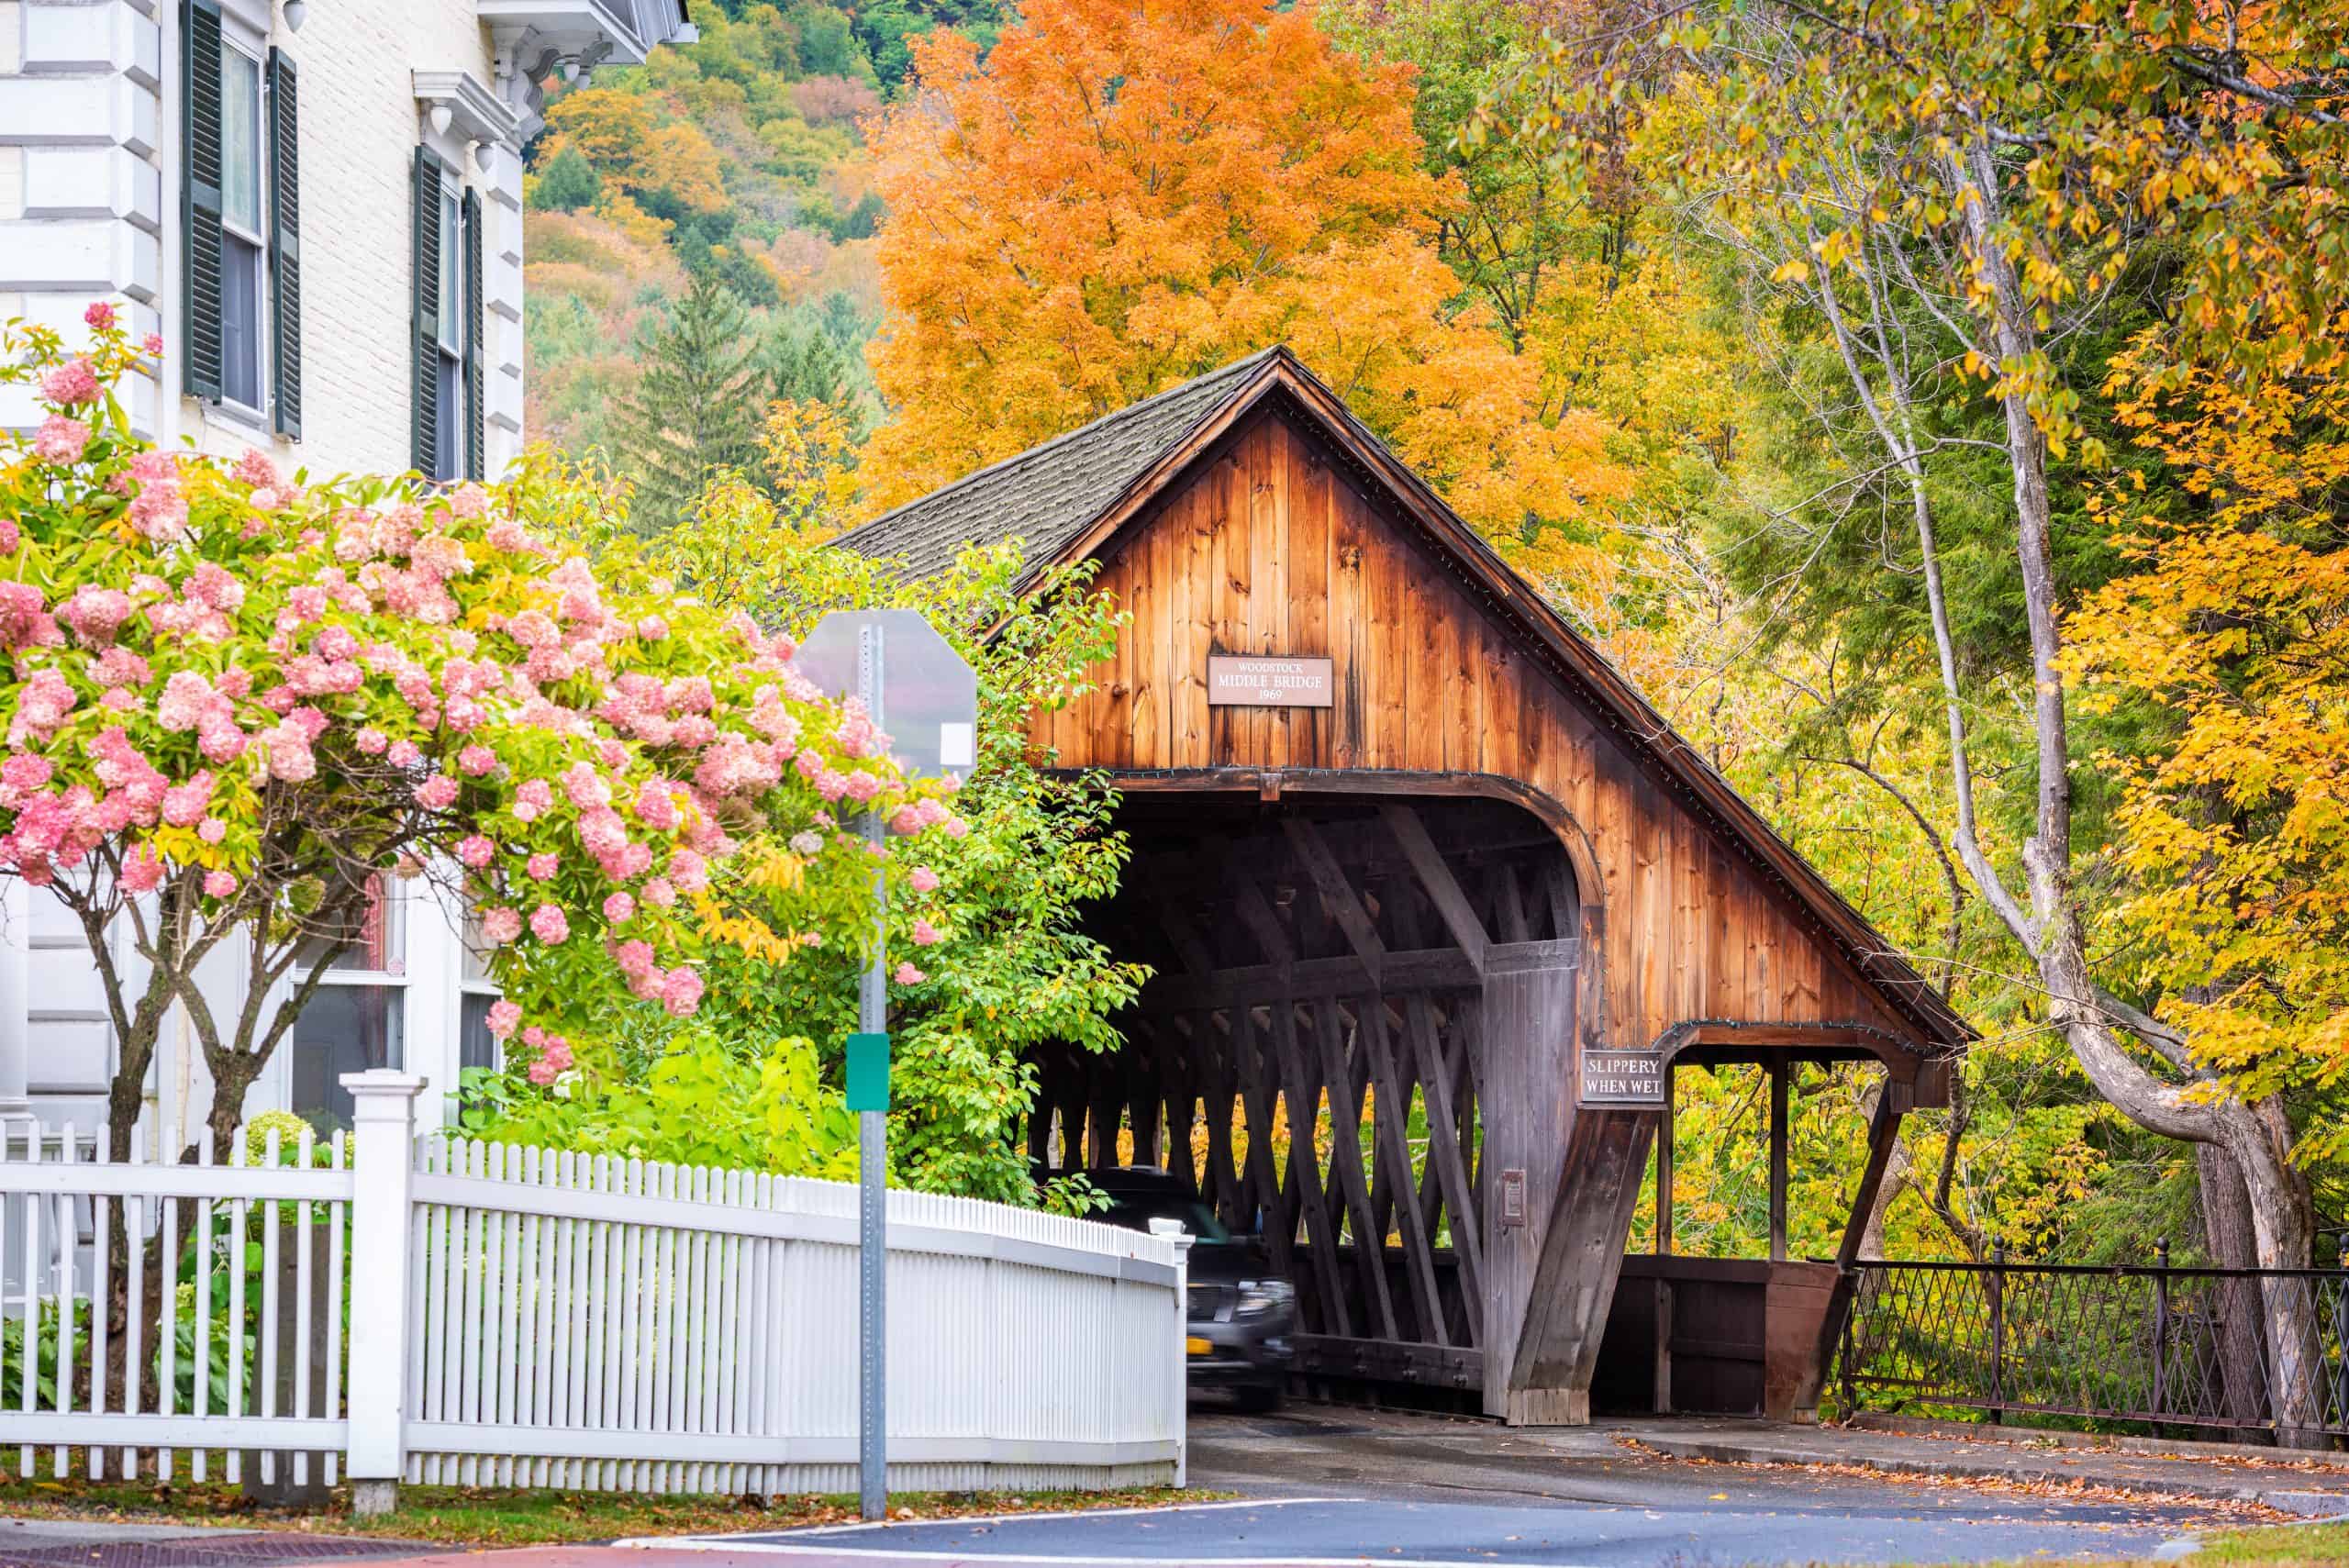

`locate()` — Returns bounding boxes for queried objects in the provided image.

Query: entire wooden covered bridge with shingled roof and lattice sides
[846,348,1966,1422]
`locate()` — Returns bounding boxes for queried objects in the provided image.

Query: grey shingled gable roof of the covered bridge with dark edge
[836,345,1973,1047]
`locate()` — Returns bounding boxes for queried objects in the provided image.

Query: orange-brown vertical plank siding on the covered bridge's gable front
[1033,406,1920,1065]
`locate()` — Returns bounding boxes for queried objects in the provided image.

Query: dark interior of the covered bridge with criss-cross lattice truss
[1029,800,1578,1361]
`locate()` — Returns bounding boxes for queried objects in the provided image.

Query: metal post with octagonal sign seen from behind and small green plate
[794,610,980,1518]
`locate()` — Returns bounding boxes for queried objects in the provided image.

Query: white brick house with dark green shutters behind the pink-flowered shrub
[0,0,691,1151]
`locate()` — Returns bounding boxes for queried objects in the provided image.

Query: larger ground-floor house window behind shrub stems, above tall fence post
[286,878,408,1131]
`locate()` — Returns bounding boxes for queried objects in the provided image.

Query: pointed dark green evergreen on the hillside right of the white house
[616,272,766,533]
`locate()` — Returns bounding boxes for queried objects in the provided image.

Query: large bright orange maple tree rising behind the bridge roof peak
[863,0,1631,551]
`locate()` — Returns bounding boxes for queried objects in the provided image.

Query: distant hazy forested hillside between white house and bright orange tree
[526,0,996,453]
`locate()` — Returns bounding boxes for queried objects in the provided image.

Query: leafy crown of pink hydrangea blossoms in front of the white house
[0,328,968,1082]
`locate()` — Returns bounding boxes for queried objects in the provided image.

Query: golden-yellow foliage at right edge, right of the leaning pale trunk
[2067,339,2349,1160]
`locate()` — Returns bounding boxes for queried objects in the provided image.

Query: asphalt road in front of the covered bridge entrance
[619,1408,2218,1568]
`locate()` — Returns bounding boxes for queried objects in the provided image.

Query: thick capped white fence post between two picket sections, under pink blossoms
[343,1068,425,1514]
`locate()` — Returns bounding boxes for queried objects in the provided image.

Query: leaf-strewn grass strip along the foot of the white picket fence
[0,1481,1229,1547]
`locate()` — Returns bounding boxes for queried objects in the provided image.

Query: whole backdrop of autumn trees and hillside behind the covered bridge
[509,0,2349,1262]
